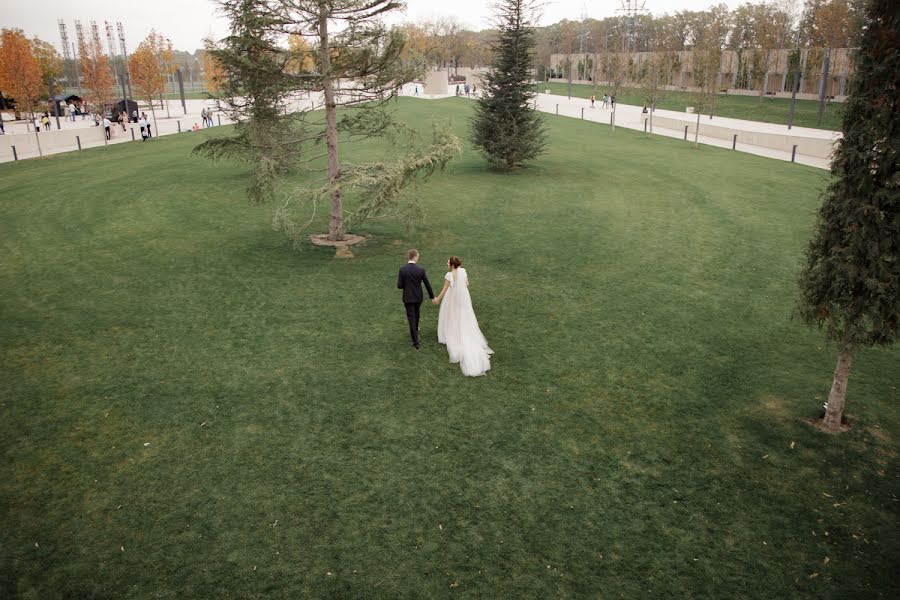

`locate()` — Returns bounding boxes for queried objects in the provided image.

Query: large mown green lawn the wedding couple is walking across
[0,98,900,600]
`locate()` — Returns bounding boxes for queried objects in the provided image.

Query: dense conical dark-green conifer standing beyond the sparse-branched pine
[471,0,547,170]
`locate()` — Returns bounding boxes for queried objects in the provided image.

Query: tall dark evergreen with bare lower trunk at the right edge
[800,0,900,432]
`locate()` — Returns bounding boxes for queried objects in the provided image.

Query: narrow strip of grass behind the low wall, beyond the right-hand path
[537,81,844,131]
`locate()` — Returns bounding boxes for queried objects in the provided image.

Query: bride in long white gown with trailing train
[432,256,494,377]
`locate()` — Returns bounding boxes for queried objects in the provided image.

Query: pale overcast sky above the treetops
[0,0,758,52]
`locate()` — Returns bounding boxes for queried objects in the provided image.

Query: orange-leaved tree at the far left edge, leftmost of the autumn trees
[0,29,44,116]
